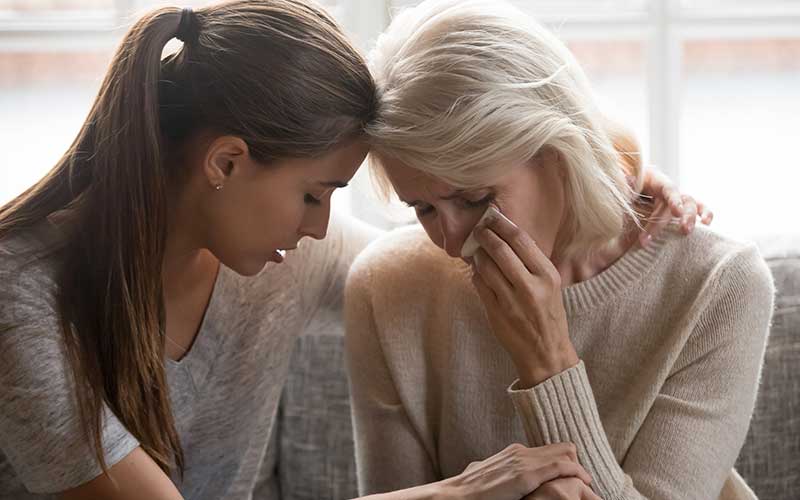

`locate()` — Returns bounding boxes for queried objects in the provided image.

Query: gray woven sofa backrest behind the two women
[270,238,800,500]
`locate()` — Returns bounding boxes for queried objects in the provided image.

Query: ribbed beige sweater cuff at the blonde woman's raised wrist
[508,361,625,499]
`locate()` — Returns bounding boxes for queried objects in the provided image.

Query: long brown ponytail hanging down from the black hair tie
[0,8,189,471]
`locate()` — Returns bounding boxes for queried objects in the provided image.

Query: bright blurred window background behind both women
[0,0,800,237]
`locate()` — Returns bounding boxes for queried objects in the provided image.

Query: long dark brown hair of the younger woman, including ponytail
[0,0,376,472]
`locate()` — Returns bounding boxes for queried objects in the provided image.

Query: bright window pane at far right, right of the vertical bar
[680,39,800,236]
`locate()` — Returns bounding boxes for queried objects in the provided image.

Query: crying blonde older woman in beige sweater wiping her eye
[346,0,773,500]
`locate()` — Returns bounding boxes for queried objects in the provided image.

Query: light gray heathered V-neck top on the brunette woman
[0,213,374,500]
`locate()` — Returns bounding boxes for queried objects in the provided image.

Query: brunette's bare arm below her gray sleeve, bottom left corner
[60,448,183,500]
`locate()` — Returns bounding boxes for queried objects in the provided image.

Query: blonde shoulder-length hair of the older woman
[367,0,635,256]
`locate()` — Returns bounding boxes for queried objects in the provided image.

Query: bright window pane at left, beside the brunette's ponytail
[0,53,111,204]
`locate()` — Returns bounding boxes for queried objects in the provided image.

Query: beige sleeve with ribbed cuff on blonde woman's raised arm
[509,247,774,500]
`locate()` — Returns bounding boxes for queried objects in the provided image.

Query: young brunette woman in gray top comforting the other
[0,0,708,500]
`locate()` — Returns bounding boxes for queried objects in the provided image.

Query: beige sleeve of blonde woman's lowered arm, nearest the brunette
[345,263,439,495]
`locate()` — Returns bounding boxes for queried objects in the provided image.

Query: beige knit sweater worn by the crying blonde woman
[346,227,774,500]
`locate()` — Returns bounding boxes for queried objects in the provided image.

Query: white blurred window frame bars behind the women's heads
[0,0,800,204]
